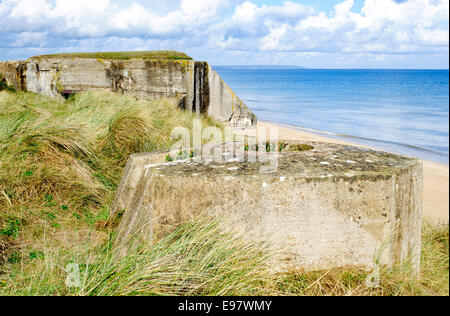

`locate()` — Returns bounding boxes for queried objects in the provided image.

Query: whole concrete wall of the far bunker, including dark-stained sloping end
[0,57,257,127]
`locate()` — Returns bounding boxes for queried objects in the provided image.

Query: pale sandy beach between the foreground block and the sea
[244,121,449,223]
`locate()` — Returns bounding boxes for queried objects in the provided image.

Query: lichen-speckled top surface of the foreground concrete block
[148,142,419,181]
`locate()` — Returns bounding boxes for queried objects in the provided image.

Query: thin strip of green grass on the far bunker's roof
[35,50,192,60]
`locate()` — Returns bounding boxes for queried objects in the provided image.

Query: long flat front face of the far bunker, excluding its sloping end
[22,58,194,99]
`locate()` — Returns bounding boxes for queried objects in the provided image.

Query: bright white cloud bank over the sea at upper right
[224,0,449,54]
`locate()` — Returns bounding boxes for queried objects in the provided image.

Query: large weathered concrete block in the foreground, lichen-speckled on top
[112,142,422,271]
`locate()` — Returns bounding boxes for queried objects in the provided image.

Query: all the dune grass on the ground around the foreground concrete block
[0,91,449,296]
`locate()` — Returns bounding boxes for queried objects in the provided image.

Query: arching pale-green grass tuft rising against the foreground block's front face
[77,220,269,296]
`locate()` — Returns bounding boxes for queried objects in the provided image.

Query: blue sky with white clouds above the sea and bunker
[0,0,449,69]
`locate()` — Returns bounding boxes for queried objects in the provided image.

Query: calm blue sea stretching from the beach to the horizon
[215,67,449,164]
